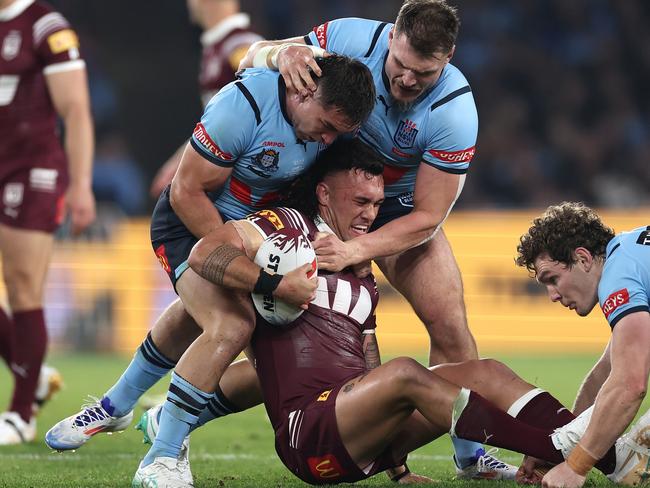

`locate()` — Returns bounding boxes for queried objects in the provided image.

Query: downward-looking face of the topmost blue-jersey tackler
[384,31,454,104]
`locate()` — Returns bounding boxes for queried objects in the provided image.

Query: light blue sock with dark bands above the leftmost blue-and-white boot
[102,333,176,417]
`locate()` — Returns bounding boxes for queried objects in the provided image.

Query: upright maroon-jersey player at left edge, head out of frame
[0,0,95,445]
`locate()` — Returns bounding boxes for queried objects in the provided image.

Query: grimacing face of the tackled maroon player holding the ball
[317,169,384,241]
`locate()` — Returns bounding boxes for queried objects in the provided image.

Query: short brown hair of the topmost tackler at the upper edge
[395,0,460,57]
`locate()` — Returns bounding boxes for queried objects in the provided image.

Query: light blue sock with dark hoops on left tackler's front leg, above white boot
[142,373,212,466]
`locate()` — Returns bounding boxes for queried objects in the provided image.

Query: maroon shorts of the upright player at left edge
[0,157,68,233]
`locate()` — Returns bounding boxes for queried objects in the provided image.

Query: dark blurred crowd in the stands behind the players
[52,0,650,215]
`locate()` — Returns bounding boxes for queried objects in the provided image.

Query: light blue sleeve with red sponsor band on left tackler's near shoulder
[190,81,257,168]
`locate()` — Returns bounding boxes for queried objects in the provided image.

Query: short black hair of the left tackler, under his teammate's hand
[316,54,375,129]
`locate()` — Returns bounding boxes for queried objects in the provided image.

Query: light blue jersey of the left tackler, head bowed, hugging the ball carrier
[190,69,319,219]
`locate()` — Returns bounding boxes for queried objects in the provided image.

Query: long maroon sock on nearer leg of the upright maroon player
[9,308,47,422]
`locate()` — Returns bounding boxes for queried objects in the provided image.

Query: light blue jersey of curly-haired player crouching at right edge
[598,226,650,327]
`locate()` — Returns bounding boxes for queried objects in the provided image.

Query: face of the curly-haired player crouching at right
[535,254,599,317]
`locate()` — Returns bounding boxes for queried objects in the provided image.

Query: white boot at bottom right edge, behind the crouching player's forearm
[607,410,650,486]
